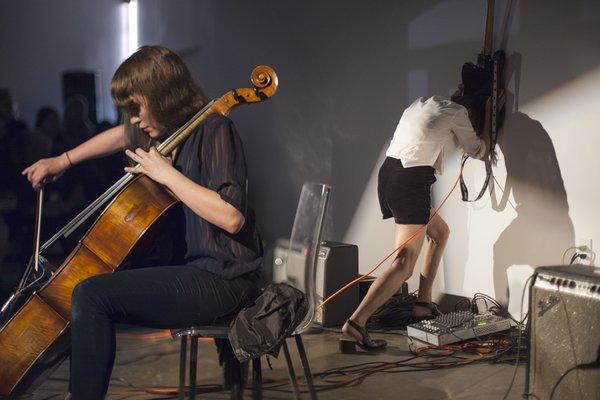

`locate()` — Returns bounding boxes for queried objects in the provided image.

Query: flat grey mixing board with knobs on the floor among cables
[406,311,510,346]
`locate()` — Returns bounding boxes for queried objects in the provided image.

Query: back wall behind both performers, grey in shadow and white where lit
[0,0,600,310]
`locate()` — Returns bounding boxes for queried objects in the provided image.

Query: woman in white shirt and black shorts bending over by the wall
[340,85,490,352]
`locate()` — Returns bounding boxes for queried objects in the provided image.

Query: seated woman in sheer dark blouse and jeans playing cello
[23,46,263,400]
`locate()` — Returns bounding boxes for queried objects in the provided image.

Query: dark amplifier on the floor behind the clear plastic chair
[273,240,358,327]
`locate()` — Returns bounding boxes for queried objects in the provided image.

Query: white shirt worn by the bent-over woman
[385,95,485,174]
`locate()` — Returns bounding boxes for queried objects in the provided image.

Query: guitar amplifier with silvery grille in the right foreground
[527,265,600,400]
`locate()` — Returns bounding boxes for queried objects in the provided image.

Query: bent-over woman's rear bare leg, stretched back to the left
[342,224,425,340]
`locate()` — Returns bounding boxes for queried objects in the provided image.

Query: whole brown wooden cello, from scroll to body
[0,65,278,398]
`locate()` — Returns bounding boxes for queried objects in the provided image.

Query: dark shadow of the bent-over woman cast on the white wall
[492,53,575,304]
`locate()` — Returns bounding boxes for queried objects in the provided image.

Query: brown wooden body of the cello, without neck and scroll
[0,176,178,397]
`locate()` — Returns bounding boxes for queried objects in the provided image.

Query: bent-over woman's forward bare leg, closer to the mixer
[412,211,450,316]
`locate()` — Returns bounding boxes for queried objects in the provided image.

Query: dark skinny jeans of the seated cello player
[70,265,257,400]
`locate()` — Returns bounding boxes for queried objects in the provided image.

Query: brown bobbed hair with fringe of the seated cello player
[110,46,207,149]
